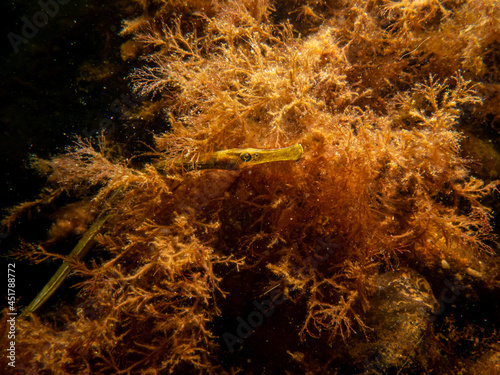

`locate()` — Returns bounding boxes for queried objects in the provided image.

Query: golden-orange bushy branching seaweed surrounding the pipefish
[2,0,500,374]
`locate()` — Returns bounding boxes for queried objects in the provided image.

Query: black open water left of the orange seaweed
[0,0,137,312]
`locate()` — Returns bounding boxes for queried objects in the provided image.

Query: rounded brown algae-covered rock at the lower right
[352,268,439,374]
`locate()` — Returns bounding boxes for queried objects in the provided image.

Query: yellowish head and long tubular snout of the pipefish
[174,144,304,170]
